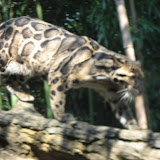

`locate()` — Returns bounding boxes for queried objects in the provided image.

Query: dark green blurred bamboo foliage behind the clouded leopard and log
[0,0,160,131]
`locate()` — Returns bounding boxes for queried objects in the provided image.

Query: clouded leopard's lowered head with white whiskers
[111,59,144,101]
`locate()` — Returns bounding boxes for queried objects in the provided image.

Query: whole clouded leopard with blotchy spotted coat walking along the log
[0,17,143,128]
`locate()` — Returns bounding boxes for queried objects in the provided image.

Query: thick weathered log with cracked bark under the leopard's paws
[0,101,160,160]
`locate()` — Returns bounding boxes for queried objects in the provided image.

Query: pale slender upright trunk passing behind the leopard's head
[115,0,148,129]
